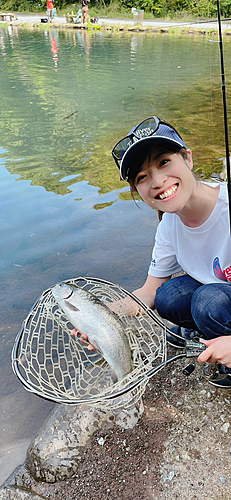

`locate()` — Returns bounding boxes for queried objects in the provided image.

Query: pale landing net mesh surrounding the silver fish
[12,277,166,410]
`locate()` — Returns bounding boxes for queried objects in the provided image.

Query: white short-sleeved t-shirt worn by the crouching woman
[149,183,231,284]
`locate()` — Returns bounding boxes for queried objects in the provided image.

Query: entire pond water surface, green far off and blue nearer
[0,28,231,483]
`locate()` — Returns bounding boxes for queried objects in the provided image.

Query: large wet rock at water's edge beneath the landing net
[26,404,143,483]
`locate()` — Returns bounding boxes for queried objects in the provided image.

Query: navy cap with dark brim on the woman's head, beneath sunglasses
[120,123,188,180]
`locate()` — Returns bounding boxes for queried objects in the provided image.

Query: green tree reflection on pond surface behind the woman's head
[0,28,231,201]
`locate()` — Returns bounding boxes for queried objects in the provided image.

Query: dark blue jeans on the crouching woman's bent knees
[155,275,231,339]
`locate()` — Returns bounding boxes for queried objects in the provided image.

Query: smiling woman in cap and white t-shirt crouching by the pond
[112,117,231,387]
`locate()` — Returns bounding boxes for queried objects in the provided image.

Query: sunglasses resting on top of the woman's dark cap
[112,116,182,174]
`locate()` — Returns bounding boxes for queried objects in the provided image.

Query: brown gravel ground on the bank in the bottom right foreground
[7,349,231,500]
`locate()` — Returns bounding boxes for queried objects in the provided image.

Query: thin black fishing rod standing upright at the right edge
[217,0,231,231]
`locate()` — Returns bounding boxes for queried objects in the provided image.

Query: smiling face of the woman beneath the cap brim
[135,149,196,215]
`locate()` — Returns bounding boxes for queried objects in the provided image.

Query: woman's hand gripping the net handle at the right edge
[197,335,231,368]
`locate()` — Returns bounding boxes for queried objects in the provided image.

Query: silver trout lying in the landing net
[52,283,132,383]
